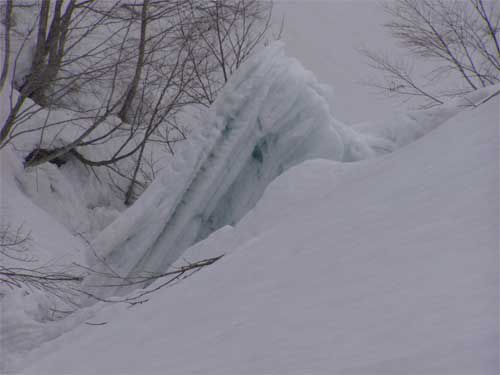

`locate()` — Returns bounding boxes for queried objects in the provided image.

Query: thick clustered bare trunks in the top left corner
[0,0,126,148]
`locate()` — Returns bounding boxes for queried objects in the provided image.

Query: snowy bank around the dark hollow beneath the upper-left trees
[0,87,124,238]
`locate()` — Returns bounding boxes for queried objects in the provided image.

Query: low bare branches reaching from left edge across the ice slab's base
[0,224,224,320]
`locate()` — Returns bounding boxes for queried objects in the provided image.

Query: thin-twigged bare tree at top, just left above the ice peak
[182,0,273,106]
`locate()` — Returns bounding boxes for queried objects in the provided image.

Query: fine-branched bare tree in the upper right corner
[362,0,500,107]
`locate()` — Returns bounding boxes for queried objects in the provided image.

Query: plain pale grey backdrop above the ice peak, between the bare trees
[274,0,404,123]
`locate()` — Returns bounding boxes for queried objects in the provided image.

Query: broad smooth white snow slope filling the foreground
[24,93,499,375]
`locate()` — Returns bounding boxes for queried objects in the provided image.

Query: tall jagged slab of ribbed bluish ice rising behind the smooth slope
[87,44,498,295]
